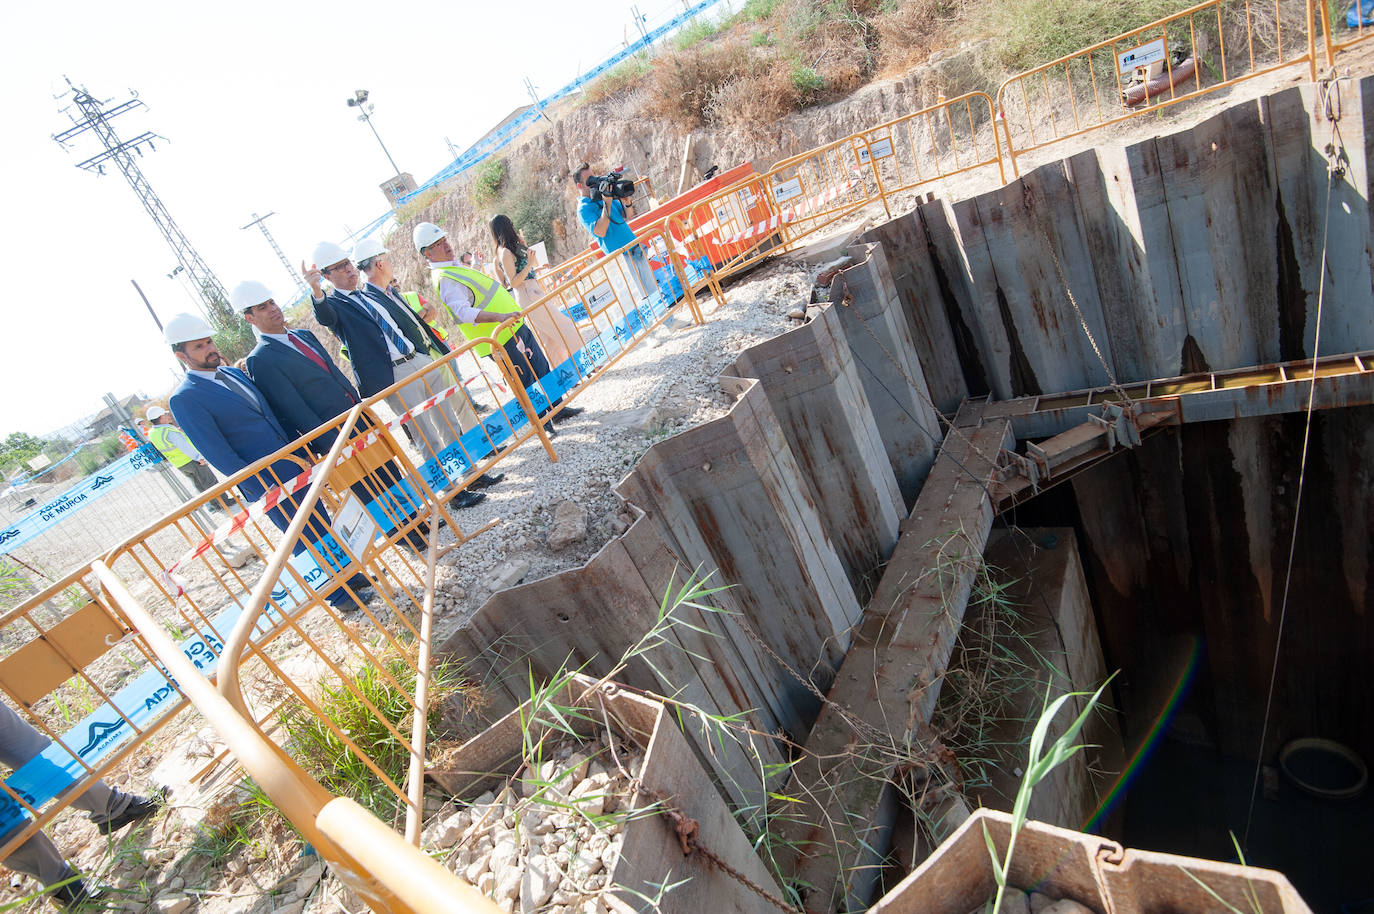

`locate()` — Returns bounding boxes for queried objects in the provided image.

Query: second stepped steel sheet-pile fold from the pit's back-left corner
[734,305,904,598]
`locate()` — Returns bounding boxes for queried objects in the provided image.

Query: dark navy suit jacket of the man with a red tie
[247,330,361,455]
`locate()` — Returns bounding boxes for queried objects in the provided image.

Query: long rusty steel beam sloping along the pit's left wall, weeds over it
[783,418,1013,914]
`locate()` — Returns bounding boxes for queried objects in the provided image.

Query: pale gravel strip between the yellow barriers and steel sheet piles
[423,261,815,640]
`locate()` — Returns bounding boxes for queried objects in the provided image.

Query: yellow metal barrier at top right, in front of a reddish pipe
[998,0,1316,175]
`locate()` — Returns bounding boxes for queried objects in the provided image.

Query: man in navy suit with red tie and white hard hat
[229,280,439,550]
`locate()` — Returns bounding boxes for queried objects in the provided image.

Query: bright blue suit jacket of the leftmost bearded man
[170,368,304,500]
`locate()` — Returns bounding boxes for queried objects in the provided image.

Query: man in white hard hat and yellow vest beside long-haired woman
[412,223,581,432]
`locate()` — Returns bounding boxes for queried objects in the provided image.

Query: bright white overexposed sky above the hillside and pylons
[0,0,708,437]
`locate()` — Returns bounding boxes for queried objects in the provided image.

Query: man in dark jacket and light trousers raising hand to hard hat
[301,242,496,507]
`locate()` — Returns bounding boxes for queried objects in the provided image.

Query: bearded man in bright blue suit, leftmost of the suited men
[164,315,371,610]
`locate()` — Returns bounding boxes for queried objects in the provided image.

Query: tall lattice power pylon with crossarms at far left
[52,80,235,330]
